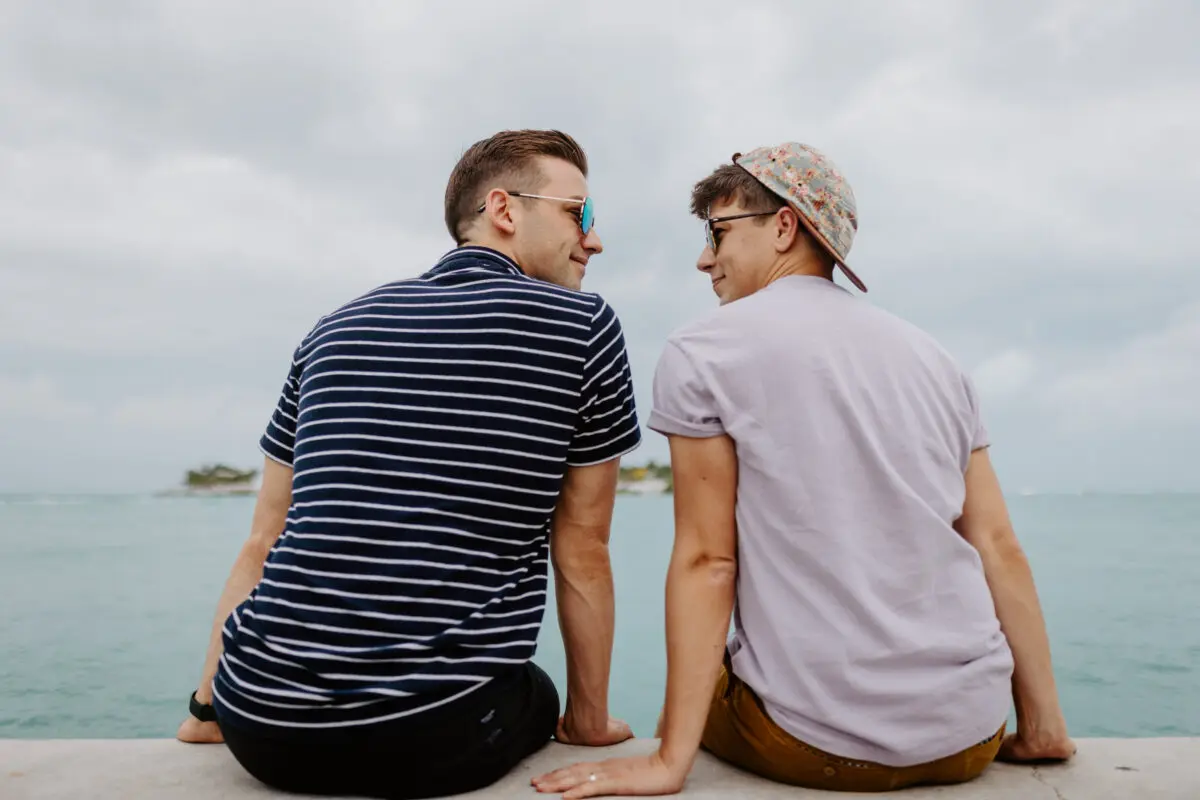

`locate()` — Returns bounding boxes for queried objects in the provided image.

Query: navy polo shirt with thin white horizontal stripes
[214,247,641,728]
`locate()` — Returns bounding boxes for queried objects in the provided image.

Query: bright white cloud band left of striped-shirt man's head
[0,145,446,279]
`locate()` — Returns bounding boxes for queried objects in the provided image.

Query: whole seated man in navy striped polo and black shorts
[179,131,641,798]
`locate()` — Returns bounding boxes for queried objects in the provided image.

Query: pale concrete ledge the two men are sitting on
[0,739,1200,800]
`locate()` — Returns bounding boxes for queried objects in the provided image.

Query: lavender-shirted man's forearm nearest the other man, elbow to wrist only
[661,557,737,771]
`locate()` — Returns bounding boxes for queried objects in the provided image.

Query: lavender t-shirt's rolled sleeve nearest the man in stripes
[647,341,725,438]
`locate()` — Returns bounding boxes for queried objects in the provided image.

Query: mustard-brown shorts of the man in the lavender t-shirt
[701,656,1004,792]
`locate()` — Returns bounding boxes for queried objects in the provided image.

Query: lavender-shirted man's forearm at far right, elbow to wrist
[979,537,1062,726]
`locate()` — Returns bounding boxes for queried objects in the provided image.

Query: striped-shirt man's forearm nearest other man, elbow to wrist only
[554,543,614,732]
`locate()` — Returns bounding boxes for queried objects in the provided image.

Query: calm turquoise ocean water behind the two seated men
[0,495,1200,739]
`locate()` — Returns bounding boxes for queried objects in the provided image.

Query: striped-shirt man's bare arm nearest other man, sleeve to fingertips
[550,459,632,745]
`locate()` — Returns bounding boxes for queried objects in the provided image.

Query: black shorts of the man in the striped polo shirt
[220,663,559,800]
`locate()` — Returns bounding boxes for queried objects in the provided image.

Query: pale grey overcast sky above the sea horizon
[0,0,1200,492]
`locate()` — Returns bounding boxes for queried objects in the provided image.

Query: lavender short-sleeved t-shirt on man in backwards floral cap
[649,276,1013,766]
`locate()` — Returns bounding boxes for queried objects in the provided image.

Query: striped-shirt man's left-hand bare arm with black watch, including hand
[176,458,292,742]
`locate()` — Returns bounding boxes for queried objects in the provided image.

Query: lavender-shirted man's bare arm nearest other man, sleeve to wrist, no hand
[660,435,738,786]
